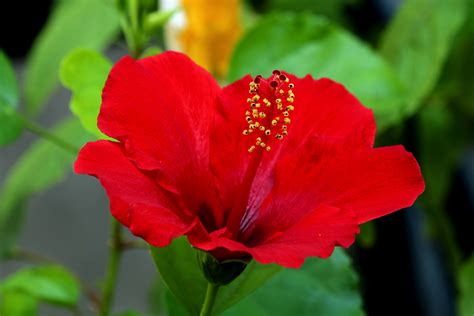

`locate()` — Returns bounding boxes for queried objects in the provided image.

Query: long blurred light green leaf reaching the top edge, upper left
[25,0,119,113]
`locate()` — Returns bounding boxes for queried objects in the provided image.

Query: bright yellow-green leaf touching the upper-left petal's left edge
[60,48,112,138]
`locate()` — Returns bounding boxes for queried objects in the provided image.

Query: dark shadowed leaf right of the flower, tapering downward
[416,101,474,268]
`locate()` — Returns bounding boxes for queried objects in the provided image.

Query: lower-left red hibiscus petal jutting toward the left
[74,141,193,246]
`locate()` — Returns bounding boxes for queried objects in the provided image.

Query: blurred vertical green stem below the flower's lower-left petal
[100,218,122,316]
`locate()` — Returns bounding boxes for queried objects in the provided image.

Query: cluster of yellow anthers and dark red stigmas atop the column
[242,70,295,153]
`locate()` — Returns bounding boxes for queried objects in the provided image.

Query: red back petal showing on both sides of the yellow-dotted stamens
[211,75,375,232]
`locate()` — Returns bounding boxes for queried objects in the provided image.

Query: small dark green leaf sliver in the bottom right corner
[458,255,474,316]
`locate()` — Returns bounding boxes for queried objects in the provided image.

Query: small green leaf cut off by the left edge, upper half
[0,50,22,146]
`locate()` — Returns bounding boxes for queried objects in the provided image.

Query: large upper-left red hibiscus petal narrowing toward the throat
[98,52,220,220]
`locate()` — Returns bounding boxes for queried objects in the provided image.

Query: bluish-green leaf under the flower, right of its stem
[223,248,364,316]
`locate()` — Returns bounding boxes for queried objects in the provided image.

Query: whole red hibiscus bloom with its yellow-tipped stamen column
[75,52,424,267]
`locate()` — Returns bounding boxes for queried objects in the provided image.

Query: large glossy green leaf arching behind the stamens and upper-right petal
[230,13,404,129]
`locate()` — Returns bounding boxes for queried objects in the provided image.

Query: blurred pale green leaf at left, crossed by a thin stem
[0,119,92,258]
